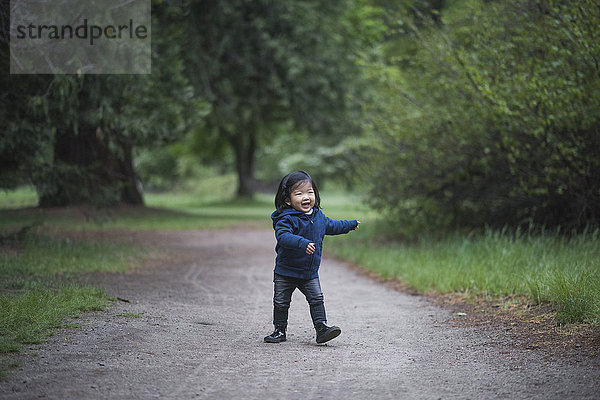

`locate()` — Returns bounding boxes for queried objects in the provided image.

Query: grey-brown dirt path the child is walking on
[0,230,600,400]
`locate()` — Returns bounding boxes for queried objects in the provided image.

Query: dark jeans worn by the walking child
[273,274,327,328]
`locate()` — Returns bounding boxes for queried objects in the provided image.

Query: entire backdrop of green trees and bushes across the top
[0,0,600,234]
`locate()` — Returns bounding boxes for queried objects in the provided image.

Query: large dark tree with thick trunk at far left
[0,0,206,206]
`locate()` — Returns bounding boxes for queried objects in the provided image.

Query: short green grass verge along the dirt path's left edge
[0,232,140,377]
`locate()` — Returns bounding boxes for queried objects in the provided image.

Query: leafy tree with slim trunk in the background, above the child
[180,0,363,196]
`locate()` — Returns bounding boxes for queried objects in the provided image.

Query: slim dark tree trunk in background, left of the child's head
[230,129,256,198]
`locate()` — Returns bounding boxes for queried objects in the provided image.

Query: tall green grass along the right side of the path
[335,226,600,323]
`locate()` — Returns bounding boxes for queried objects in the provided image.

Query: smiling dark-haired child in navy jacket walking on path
[265,171,360,343]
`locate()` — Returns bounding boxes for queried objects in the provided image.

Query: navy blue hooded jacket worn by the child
[271,208,358,279]
